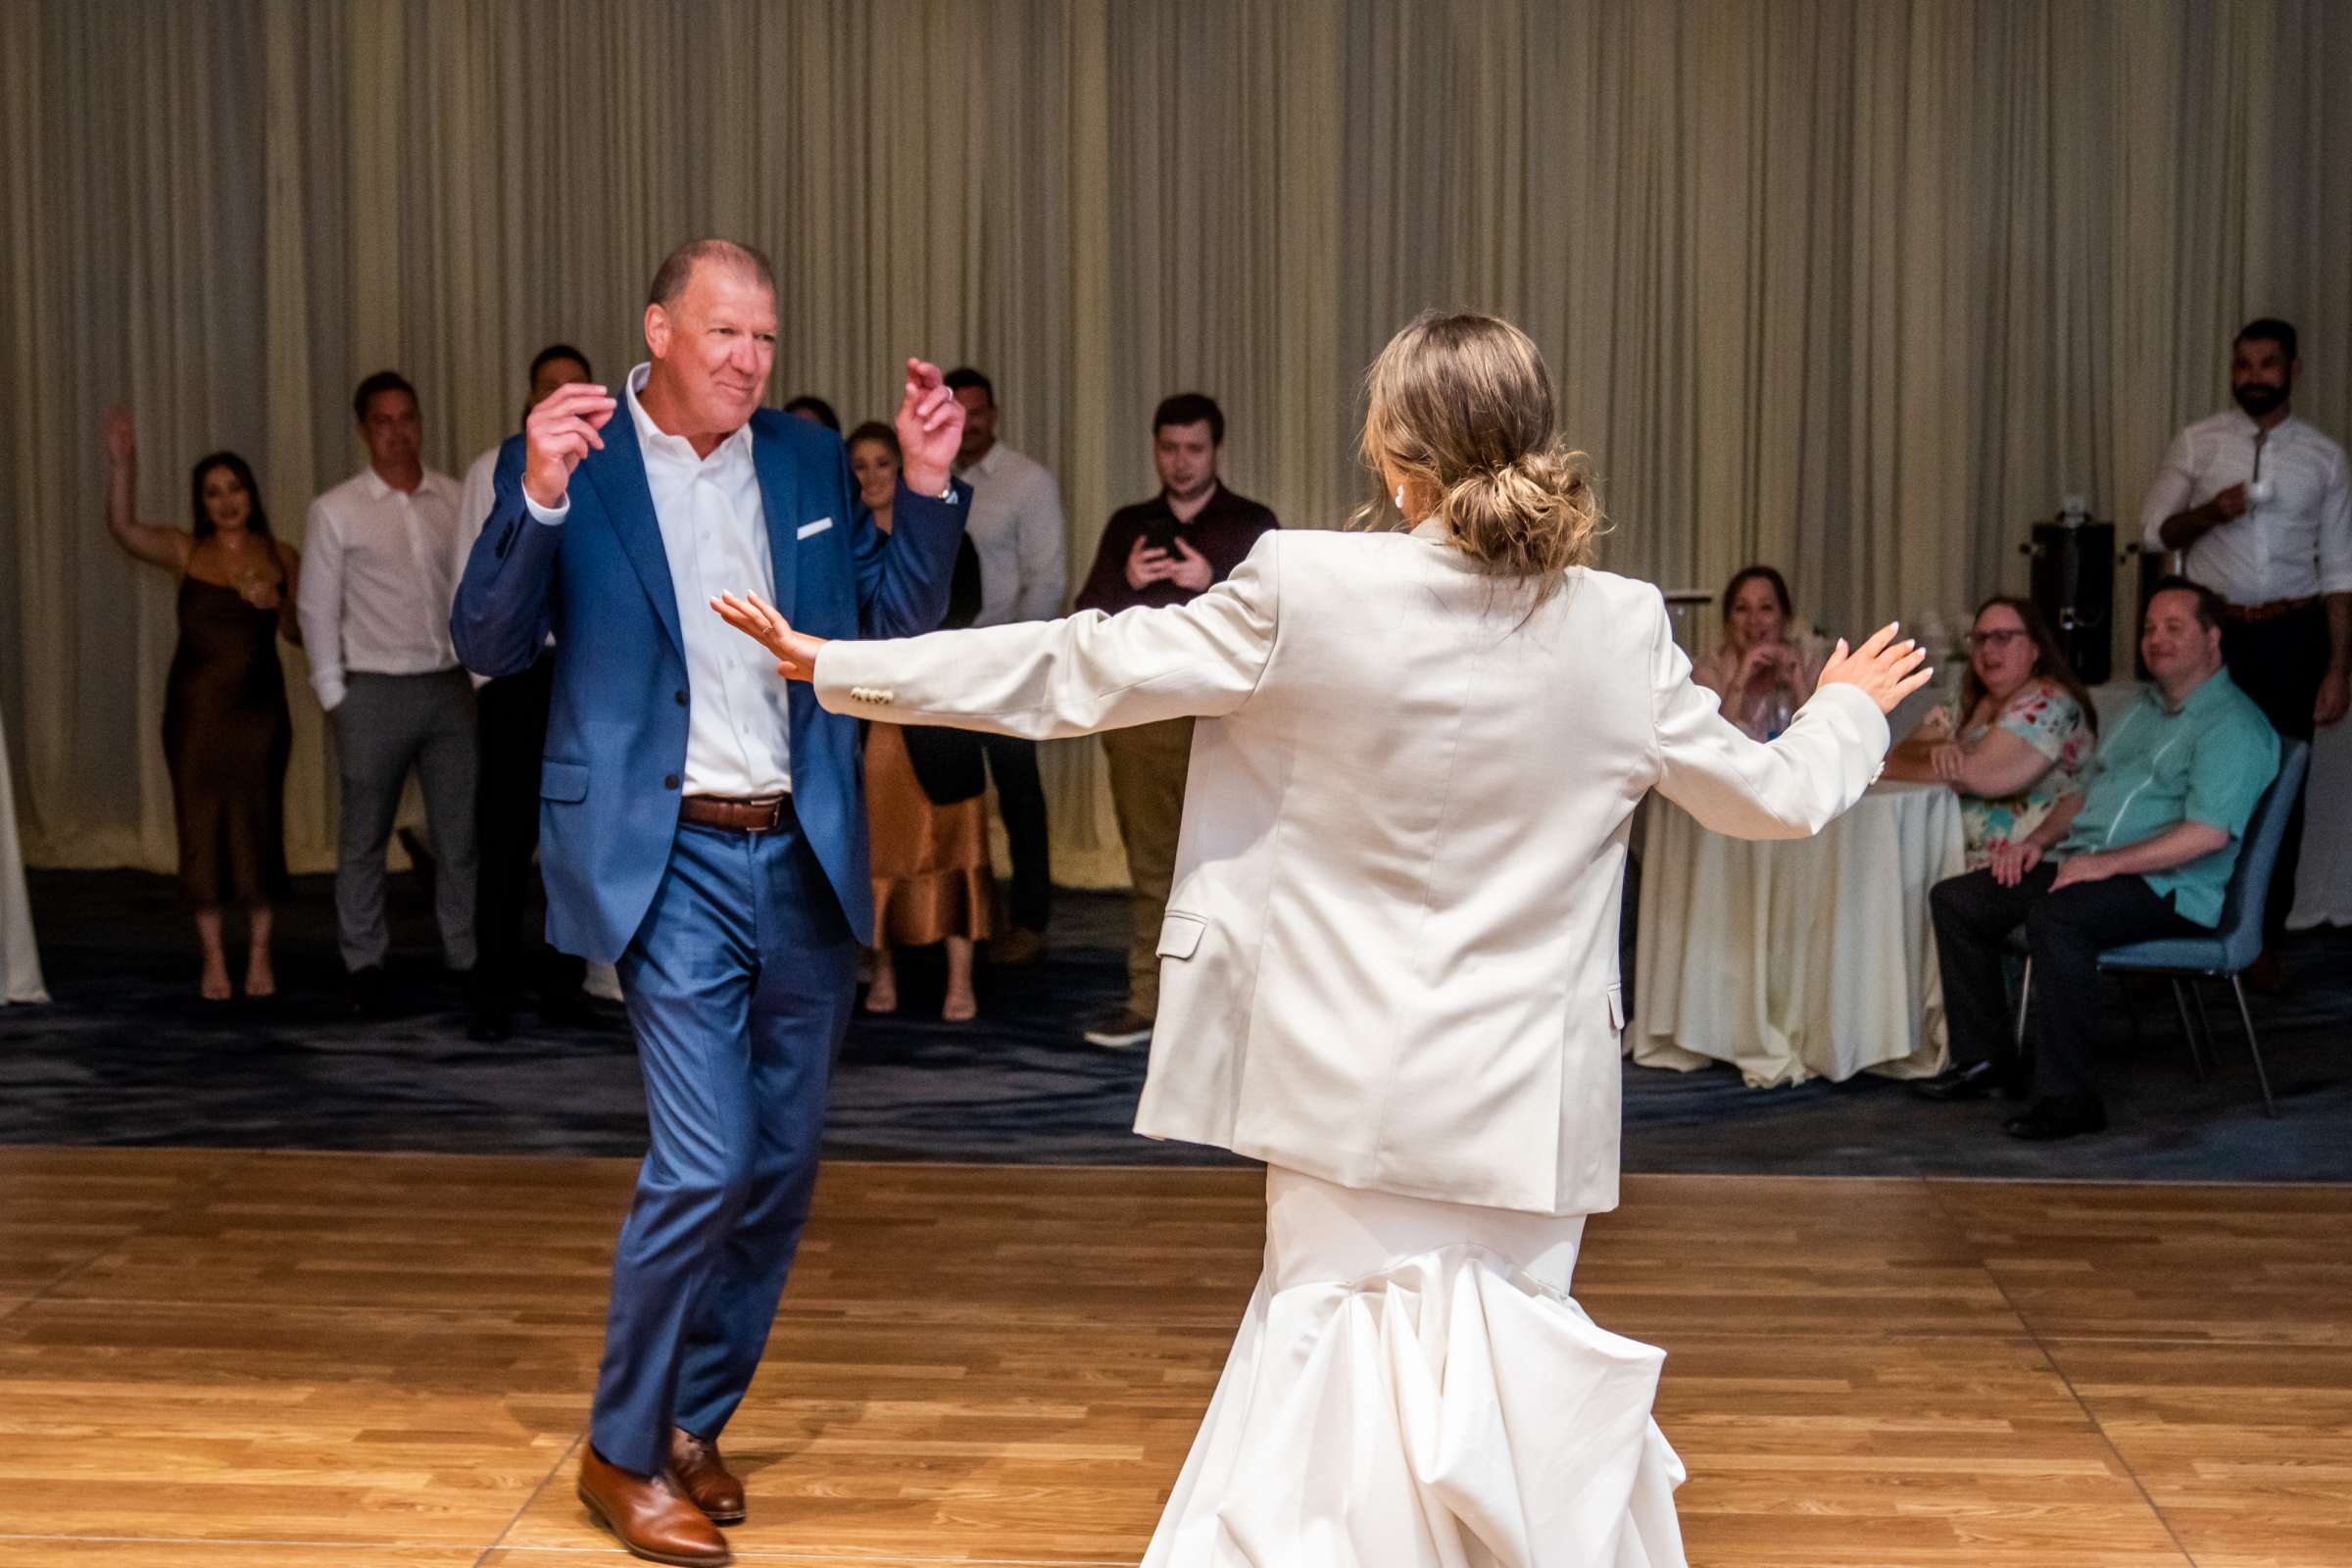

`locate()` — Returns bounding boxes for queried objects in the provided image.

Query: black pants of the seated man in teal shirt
[1929,862,2211,1098]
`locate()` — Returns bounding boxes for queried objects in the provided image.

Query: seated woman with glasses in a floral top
[1884,595,2098,870]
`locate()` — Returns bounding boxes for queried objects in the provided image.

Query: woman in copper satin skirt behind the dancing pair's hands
[847,423,995,1022]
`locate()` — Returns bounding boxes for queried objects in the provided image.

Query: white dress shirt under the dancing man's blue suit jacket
[522,365,793,800]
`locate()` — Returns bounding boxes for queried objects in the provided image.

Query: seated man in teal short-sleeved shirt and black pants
[1912,578,2279,1140]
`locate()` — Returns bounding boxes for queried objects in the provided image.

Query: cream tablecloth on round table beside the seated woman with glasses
[1625,783,1964,1089]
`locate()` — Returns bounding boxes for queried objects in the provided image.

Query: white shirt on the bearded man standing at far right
[2140,409,2352,604]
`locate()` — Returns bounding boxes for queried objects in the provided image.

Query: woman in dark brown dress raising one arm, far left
[106,409,301,1002]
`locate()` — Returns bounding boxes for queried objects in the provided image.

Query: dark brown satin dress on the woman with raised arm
[163,576,294,907]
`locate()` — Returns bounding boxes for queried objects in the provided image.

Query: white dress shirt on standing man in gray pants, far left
[294,467,459,712]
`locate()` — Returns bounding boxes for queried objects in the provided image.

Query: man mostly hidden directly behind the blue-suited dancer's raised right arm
[449,343,593,1042]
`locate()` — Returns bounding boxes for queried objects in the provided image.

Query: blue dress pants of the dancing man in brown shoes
[588,811,858,1474]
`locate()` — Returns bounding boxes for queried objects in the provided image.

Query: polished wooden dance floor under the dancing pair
[0,1148,2352,1568]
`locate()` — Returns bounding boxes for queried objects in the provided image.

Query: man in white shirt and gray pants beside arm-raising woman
[296,369,475,1010]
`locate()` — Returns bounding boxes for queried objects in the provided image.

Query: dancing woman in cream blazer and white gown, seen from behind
[717,315,1924,1568]
